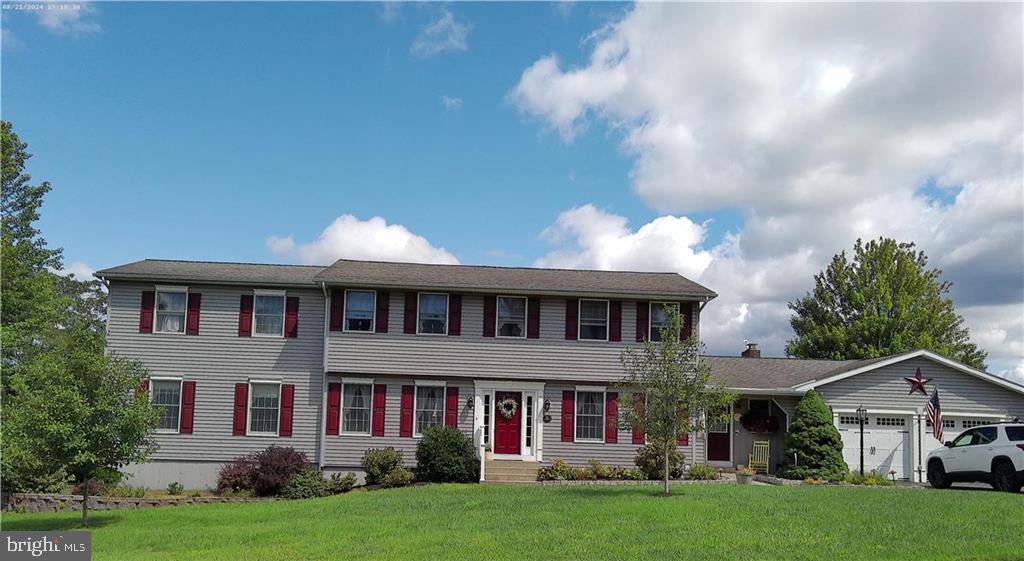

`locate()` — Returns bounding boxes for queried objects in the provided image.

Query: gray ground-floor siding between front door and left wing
[324,376,473,469]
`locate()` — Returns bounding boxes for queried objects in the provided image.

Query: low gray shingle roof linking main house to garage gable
[705,355,888,389]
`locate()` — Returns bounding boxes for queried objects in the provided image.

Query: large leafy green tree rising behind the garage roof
[785,238,987,370]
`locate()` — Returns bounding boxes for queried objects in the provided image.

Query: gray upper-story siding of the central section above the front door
[327,292,697,383]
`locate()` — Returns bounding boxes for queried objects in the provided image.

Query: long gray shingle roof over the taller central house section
[316,259,717,299]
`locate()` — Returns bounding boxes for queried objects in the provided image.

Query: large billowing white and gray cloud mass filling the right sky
[520,3,1024,380]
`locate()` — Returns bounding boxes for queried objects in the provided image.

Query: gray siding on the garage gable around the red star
[817,357,1024,417]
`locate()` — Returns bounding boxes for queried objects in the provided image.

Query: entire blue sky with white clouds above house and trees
[0,2,1024,381]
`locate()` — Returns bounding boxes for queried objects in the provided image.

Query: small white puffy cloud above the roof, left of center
[266,214,459,265]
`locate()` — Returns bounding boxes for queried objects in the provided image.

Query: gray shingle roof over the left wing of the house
[96,259,324,287]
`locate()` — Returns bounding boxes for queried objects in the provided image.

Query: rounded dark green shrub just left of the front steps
[416,427,480,483]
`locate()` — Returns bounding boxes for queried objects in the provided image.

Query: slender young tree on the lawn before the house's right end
[620,306,735,495]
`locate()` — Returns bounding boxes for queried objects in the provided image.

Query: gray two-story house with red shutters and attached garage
[96,260,1024,487]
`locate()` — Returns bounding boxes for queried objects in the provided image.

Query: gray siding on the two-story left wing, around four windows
[106,282,324,462]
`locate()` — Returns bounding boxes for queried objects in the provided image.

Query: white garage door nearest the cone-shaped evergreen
[839,415,913,479]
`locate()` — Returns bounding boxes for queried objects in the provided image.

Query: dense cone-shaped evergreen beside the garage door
[779,390,849,481]
